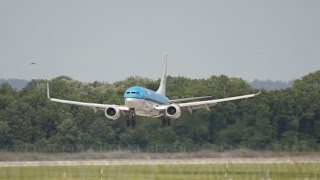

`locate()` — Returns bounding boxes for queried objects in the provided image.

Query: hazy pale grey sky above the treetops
[0,0,320,82]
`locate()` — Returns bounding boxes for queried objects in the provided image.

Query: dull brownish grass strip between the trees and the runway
[0,149,319,161]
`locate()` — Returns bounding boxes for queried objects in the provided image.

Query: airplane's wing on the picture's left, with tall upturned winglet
[47,84,129,111]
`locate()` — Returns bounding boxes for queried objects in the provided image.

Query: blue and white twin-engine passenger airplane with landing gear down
[47,54,261,127]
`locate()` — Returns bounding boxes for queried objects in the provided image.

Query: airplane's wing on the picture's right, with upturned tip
[155,90,261,113]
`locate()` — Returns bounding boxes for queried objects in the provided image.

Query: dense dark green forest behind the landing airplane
[0,71,320,152]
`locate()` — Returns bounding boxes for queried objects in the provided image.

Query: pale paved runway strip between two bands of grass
[0,157,320,167]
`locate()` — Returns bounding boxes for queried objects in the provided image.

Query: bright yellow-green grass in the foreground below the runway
[0,163,320,180]
